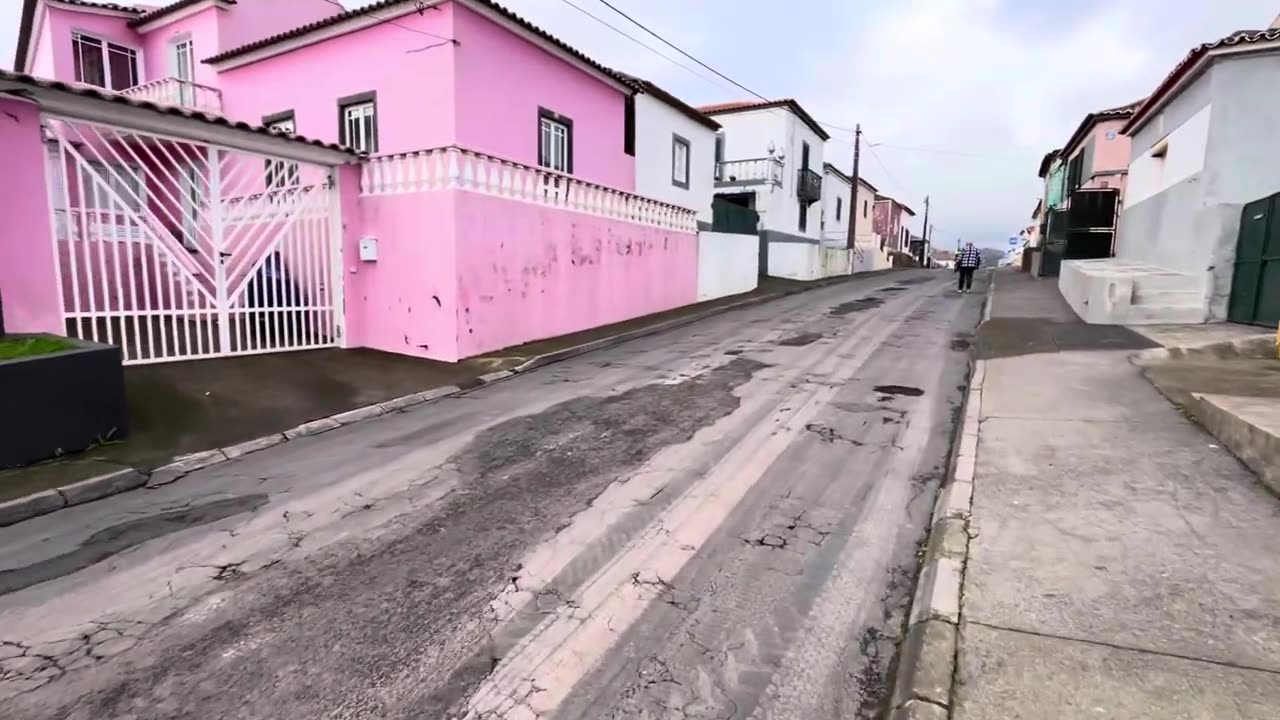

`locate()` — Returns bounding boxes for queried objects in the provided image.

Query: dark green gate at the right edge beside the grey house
[1229,193,1280,328]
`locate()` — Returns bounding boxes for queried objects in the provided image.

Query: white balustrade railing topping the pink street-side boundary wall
[360,147,698,232]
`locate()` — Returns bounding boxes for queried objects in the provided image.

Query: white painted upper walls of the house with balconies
[714,108,824,238]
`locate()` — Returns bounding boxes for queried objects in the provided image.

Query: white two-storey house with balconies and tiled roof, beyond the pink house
[699,99,851,279]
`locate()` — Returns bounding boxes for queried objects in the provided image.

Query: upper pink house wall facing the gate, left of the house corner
[219,4,458,155]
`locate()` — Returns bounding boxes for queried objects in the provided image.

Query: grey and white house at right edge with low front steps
[1060,28,1280,327]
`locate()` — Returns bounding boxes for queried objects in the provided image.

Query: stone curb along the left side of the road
[0,268,906,525]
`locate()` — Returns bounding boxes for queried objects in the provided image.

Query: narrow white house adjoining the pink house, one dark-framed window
[627,76,721,228]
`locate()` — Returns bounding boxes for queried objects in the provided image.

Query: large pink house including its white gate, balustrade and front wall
[0,0,698,361]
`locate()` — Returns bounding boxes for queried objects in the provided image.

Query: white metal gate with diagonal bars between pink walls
[45,115,342,364]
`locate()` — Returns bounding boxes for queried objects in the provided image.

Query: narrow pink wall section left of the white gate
[0,99,64,334]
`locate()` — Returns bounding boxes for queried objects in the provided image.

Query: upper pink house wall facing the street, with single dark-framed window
[453,4,635,191]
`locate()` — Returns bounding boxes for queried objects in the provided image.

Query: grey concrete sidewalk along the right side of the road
[950,273,1280,720]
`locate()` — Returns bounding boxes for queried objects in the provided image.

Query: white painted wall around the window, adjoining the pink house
[636,94,716,223]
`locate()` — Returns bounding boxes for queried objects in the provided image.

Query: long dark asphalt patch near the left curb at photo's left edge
[0,493,268,596]
